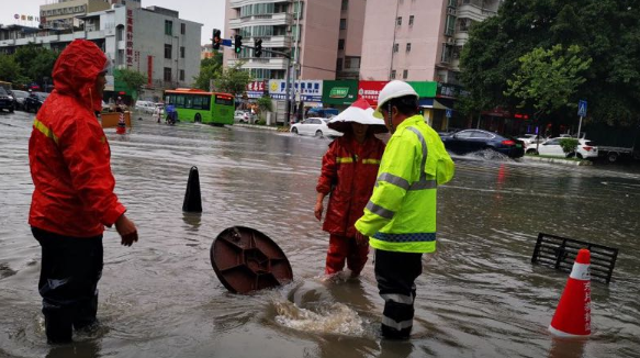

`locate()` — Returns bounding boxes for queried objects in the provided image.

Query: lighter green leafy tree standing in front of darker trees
[504,45,592,121]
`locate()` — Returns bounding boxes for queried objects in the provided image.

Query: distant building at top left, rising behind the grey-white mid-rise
[40,0,140,29]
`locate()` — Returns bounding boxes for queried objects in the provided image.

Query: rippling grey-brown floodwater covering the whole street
[0,113,640,358]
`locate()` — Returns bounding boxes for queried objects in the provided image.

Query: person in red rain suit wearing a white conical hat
[314,99,386,277]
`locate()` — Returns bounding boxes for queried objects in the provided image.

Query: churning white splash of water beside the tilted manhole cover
[274,301,364,337]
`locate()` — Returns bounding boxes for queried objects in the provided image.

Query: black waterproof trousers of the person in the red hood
[31,227,103,343]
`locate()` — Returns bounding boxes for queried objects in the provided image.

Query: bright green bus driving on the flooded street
[164,88,235,125]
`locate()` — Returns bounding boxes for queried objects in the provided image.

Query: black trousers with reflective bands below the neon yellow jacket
[375,250,422,339]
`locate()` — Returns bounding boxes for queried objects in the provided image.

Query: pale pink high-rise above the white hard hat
[360,0,502,84]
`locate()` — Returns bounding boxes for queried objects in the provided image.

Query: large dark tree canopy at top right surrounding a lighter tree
[460,0,640,124]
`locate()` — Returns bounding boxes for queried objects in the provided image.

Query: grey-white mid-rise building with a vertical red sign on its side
[0,5,202,96]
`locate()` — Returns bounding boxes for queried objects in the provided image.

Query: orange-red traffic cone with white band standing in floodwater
[549,249,591,337]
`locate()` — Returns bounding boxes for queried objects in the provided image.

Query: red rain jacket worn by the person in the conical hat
[316,134,384,237]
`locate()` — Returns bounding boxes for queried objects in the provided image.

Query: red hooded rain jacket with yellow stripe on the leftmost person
[29,40,125,237]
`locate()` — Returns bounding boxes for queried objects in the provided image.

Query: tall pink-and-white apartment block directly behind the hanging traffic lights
[223,0,366,80]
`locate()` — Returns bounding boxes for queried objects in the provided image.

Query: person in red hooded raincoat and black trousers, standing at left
[29,40,138,343]
